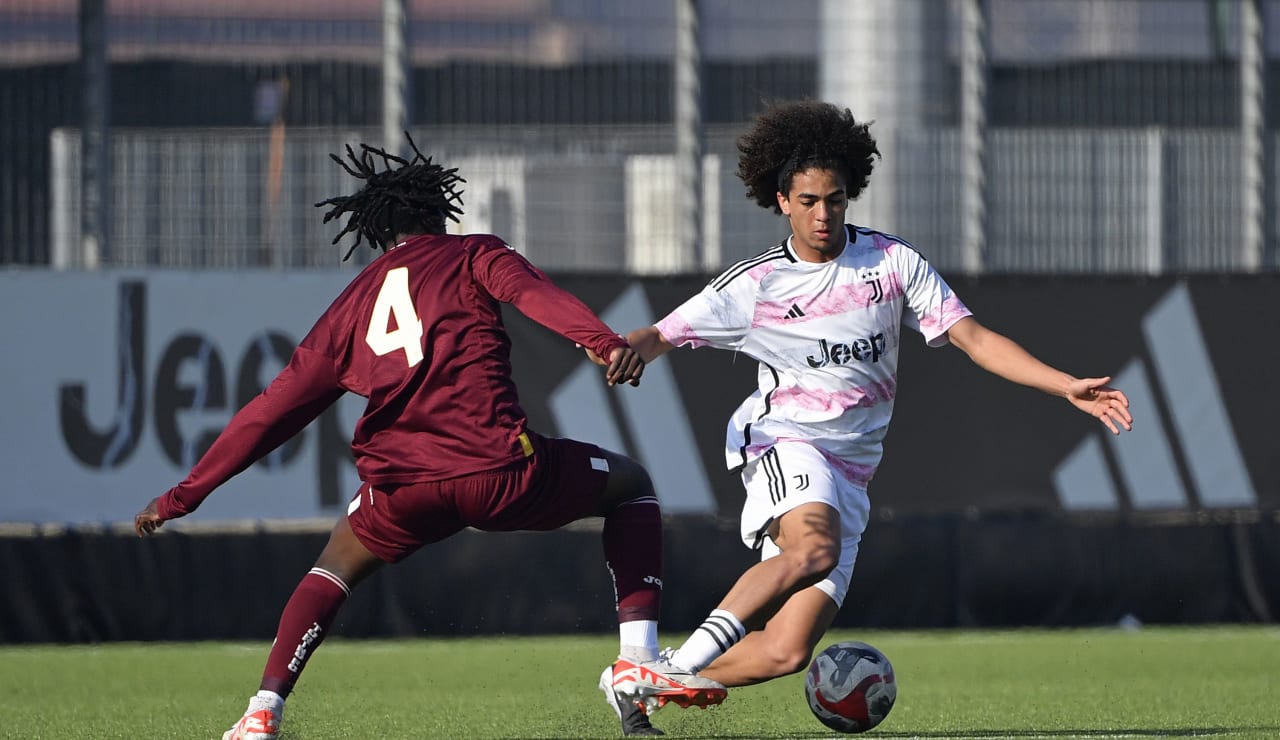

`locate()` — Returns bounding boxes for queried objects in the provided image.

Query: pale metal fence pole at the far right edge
[1240,0,1267,271]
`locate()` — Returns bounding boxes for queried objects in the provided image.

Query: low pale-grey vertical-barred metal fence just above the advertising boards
[51,128,1248,274]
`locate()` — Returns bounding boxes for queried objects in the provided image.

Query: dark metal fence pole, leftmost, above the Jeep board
[79,0,111,268]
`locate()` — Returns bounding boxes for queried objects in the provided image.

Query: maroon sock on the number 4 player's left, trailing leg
[259,568,351,696]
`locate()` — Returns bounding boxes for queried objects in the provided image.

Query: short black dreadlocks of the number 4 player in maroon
[316,131,466,261]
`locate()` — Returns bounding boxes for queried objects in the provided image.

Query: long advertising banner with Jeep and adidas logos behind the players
[0,268,1280,526]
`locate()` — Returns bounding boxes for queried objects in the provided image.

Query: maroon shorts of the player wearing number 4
[347,431,609,562]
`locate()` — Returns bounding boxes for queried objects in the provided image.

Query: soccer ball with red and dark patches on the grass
[804,641,897,732]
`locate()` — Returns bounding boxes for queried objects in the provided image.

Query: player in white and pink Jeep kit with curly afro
[602,101,1133,707]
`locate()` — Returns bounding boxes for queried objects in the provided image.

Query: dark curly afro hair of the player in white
[737,100,879,214]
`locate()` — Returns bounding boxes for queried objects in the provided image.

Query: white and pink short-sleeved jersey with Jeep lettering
[657,224,970,488]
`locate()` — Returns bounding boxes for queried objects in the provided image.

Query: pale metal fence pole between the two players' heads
[672,0,705,270]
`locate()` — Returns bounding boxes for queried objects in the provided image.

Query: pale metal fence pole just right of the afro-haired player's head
[960,0,987,275]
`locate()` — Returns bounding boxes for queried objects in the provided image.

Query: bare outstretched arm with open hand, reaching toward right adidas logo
[947,311,1133,434]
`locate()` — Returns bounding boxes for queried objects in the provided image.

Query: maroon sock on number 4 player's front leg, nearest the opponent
[604,495,662,622]
